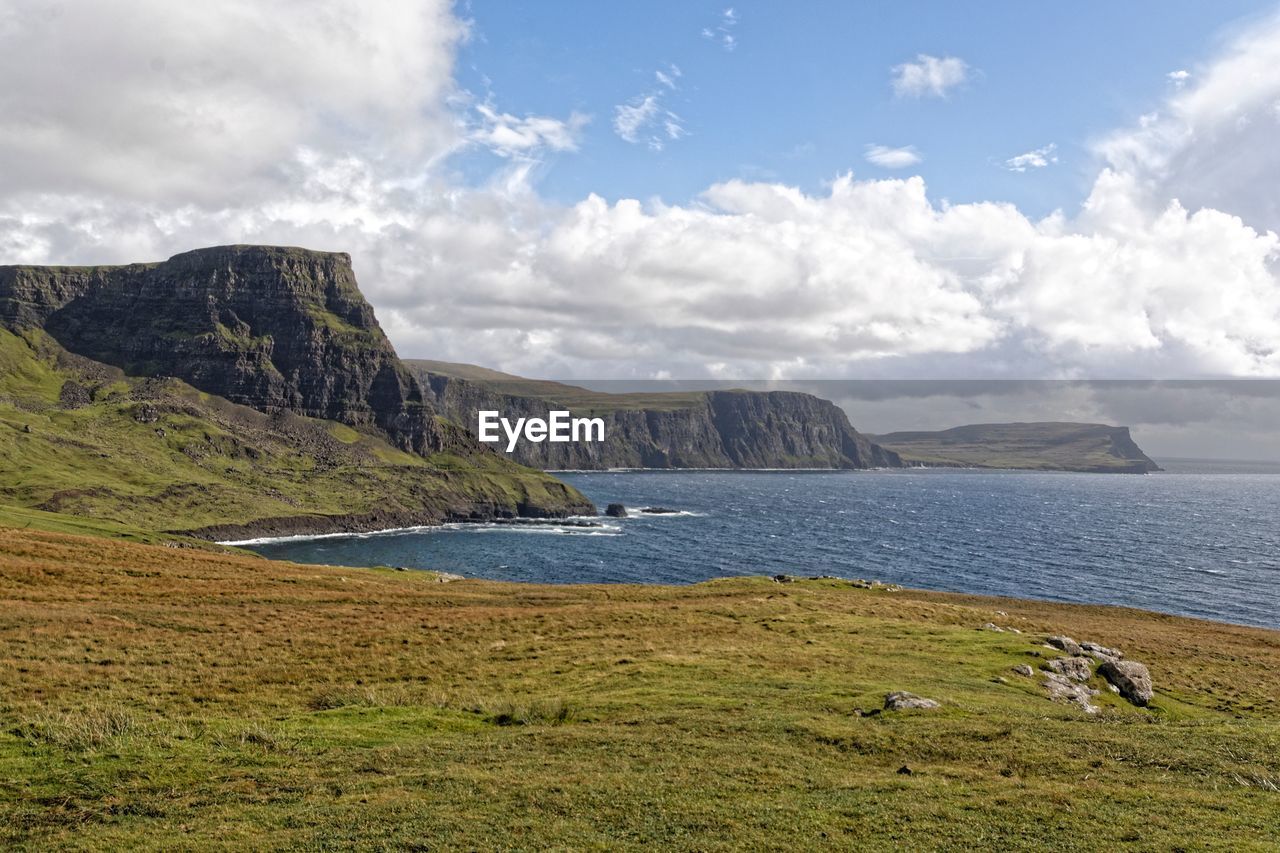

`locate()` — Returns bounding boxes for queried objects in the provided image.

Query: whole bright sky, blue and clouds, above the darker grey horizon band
[0,0,1280,379]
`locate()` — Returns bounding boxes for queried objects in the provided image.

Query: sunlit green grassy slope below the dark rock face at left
[0,328,590,538]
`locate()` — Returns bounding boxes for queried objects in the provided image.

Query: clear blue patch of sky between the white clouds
[457,0,1275,216]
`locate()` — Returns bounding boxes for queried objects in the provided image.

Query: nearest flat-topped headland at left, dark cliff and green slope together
[0,247,594,538]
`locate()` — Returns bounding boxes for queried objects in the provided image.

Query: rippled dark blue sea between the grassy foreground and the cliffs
[251,462,1280,628]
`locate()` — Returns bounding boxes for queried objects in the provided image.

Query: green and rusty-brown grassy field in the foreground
[0,529,1280,849]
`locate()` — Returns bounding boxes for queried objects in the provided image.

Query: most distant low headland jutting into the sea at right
[870,423,1160,474]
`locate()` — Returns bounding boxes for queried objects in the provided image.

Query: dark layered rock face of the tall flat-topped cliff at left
[0,246,456,453]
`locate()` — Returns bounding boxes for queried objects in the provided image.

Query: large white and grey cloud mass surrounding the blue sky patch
[0,0,1280,378]
